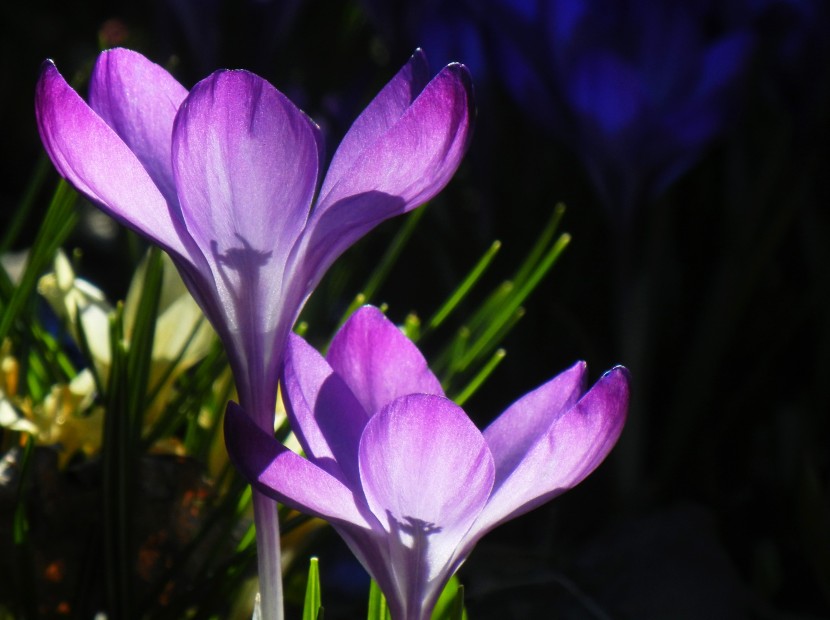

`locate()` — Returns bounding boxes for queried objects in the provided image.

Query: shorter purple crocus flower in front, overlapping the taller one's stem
[225,306,629,620]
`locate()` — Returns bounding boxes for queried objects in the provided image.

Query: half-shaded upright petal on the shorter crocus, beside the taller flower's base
[282,334,369,488]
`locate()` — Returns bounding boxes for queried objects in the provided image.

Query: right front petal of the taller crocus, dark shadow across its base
[304,64,473,274]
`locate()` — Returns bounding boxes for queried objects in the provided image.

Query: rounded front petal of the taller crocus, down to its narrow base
[173,71,319,404]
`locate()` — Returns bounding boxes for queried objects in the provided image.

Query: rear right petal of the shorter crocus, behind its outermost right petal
[484,362,587,486]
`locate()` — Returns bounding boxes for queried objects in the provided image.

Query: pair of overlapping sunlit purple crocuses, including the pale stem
[36,44,628,620]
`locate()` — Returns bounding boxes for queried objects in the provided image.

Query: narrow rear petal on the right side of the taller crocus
[320,50,429,201]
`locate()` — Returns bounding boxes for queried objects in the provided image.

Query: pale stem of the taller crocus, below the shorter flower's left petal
[253,490,284,620]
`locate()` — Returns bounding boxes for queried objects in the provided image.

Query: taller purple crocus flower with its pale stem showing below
[36,49,472,618]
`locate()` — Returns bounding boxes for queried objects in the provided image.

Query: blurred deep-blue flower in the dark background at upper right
[490,0,753,219]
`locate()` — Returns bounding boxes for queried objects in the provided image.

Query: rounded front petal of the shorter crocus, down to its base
[360,394,494,618]
